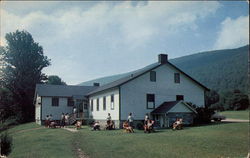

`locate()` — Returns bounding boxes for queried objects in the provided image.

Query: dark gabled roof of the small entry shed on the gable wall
[151,101,197,114]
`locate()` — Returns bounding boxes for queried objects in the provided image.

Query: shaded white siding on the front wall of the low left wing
[42,97,73,120]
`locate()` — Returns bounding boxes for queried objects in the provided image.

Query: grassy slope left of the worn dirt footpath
[9,123,75,158]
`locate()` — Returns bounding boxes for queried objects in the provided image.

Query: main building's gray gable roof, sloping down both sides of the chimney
[88,62,209,95]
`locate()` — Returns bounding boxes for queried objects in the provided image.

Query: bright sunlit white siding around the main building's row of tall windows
[89,88,119,120]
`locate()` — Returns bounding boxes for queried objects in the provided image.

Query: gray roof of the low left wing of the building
[36,84,97,98]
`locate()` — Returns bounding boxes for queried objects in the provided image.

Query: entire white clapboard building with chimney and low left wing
[35,54,209,127]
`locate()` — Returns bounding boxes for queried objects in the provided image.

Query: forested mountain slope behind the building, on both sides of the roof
[79,45,249,91]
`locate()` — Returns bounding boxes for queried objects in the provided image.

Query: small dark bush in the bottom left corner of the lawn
[0,132,12,156]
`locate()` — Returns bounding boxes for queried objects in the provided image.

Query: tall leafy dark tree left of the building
[0,30,50,122]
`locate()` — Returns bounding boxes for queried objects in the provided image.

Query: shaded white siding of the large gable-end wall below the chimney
[120,64,204,120]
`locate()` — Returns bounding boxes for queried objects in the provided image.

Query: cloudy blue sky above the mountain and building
[0,1,249,84]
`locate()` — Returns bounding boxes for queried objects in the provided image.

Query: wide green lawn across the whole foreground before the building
[4,123,249,158]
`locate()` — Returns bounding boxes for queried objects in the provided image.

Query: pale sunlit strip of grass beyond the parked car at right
[220,110,250,120]
